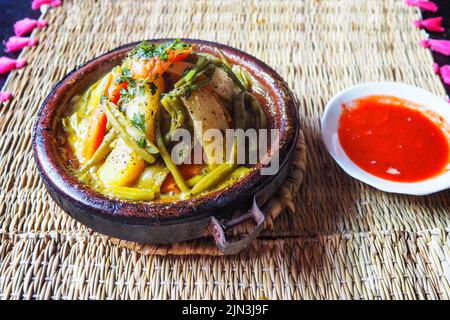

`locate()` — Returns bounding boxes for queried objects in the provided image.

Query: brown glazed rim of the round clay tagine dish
[33,38,299,224]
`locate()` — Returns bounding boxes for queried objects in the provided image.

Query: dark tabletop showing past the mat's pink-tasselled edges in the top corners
[0,0,450,95]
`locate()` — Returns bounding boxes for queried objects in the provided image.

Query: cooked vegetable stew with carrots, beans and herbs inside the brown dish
[59,40,267,201]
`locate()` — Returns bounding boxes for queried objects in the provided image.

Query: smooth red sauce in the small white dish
[338,96,449,182]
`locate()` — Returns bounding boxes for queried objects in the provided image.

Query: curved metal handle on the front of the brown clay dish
[208,197,266,255]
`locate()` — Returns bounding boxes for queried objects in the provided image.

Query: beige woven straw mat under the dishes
[0,0,450,299]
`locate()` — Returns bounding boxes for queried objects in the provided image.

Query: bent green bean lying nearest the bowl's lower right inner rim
[191,140,237,195]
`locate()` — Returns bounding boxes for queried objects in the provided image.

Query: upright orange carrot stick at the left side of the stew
[83,105,107,160]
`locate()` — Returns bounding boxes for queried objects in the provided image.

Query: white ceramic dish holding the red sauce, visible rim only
[322,82,450,196]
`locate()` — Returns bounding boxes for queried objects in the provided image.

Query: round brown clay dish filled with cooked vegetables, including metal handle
[33,39,299,242]
